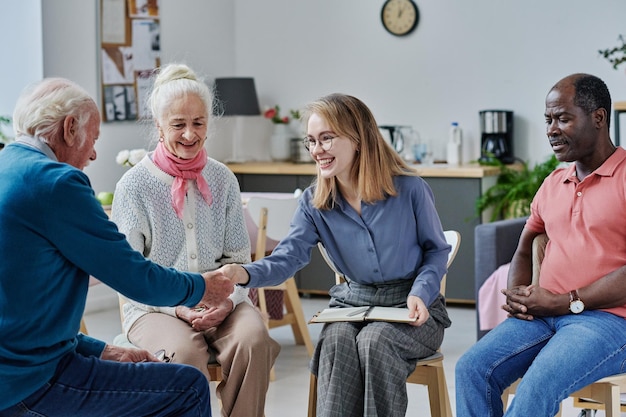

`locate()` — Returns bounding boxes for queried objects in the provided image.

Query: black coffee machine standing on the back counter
[479,110,515,164]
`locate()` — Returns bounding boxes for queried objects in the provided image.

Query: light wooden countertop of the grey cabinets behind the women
[227,162,508,178]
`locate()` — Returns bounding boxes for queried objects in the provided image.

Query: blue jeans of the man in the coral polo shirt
[455,310,626,417]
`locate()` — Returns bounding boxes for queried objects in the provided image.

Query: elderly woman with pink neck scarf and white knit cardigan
[112,64,280,417]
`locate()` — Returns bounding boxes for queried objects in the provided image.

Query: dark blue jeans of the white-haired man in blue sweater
[0,352,211,417]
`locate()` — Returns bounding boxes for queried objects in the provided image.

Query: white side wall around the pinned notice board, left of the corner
[38,0,234,192]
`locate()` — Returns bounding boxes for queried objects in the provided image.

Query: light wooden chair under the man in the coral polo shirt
[502,234,626,417]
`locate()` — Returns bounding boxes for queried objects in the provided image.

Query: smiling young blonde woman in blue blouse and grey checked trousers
[222,94,450,417]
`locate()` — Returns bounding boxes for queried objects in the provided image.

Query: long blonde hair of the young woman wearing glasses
[302,93,417,210]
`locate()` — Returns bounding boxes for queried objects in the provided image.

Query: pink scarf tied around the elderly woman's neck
[152,142,213,219]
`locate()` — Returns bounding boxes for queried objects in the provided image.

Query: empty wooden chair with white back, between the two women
[247,196,313,379]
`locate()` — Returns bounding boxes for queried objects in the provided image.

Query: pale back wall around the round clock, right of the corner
[235,0,626,166]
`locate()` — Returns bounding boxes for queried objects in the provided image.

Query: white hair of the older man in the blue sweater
[13,78,97,144]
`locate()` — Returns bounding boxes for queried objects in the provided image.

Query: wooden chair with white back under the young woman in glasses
[308,230,461,417]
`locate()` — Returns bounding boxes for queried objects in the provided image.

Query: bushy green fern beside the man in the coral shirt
[476,155,560,221]
